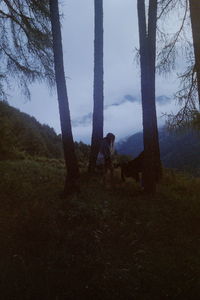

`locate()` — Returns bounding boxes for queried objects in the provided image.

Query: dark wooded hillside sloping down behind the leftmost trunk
[0,101,90,162]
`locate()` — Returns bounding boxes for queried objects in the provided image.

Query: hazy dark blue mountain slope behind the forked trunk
[116,127,200,175]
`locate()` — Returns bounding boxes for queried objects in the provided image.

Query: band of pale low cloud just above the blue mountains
[73,95,178,143]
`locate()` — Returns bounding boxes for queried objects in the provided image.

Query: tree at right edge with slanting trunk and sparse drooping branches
[158,0,200,130]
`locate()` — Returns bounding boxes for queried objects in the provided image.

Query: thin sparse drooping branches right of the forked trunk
[157,0,199,128]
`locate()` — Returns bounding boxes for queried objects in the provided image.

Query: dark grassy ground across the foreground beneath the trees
[0,160,200,300]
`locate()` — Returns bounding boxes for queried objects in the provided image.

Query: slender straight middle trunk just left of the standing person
[89,0,104,171]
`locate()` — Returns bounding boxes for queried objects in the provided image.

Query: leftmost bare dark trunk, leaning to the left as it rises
[49,0,79,193]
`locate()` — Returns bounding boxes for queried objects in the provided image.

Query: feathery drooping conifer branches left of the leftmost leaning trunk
[0,0,54,99]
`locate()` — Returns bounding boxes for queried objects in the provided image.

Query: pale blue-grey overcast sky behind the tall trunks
[9,0,189,142]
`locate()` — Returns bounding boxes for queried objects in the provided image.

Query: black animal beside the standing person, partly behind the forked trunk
[121,151,144,182]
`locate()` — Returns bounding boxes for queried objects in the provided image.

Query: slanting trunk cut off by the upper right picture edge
[189,0,200,107]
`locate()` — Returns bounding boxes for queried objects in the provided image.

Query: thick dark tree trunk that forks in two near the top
[137,0,161,193]
